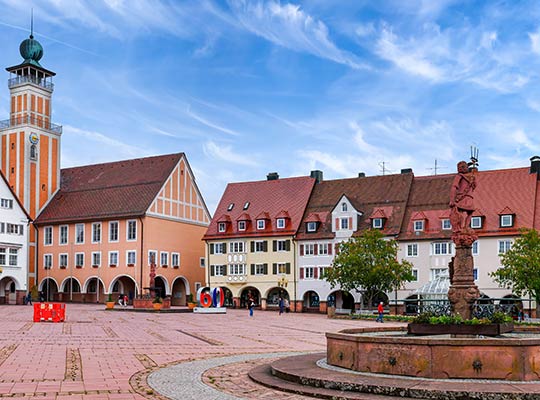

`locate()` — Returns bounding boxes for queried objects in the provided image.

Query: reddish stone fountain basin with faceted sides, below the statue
[326,327,540,381]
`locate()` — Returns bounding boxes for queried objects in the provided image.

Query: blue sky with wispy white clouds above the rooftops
[0,0,540,212]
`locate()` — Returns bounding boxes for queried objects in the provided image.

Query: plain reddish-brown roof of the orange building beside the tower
[35,153,184,225]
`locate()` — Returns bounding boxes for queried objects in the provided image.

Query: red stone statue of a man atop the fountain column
[450,161,476,234]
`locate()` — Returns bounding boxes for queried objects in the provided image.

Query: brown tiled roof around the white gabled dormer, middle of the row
[297,174,413,240]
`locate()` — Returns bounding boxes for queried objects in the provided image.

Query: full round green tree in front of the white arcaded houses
[324,229,414,305]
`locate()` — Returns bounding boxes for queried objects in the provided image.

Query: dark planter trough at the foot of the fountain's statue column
[407,322,514,336]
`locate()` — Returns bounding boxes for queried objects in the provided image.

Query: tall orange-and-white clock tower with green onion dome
[0,29,62,288]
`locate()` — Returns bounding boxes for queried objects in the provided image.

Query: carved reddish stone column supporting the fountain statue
[448,239,480,319]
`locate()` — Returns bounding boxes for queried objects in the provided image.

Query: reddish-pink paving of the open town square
[0,304,400,400]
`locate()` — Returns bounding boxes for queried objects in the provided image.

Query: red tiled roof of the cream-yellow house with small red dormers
[203,177,315,240]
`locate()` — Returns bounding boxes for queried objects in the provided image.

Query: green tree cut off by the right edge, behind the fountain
[490,229,540,315]
